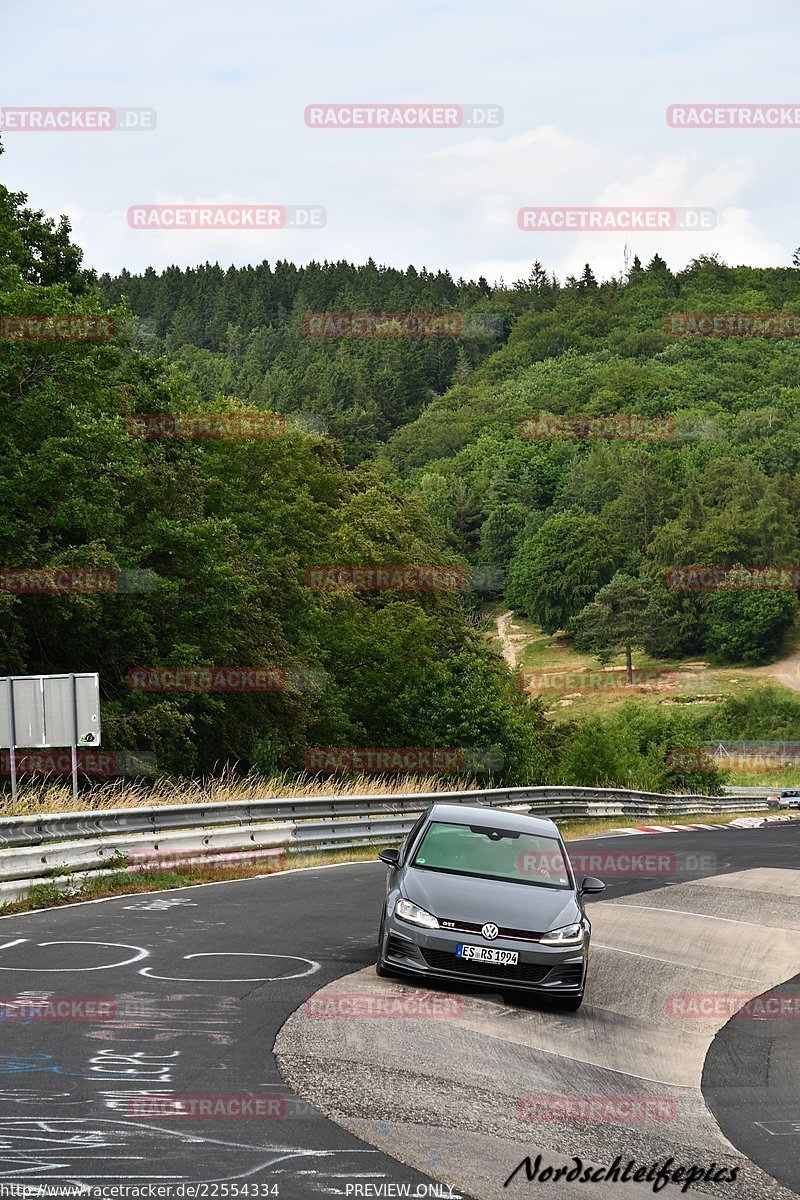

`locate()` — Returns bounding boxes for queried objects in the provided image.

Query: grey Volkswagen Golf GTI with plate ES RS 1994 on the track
[375,804,606,1009]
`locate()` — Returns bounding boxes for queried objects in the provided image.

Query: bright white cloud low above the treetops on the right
[386,126,786,282]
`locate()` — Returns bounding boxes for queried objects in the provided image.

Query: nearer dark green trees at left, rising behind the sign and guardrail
[0,142,546,779]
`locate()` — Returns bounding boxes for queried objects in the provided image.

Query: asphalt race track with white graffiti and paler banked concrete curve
[0,822,800,1200]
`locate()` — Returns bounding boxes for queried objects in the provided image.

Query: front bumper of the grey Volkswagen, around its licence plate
[380,913,589,996]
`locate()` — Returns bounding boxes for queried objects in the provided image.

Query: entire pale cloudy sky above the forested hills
[0,0,800,282]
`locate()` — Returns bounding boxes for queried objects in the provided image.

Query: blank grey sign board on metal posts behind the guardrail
[0,671,100,799]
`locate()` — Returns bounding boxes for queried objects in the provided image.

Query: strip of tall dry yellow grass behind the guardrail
[0,770,489,817]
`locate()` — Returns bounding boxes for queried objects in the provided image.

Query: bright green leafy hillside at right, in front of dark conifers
[385,260,800,664]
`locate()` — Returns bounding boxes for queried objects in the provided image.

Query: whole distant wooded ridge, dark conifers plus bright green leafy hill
[102,250,800,664]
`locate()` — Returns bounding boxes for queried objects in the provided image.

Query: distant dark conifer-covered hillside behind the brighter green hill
[100,262,506,464]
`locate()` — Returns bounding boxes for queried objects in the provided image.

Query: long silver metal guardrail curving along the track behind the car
[0,787,768,902]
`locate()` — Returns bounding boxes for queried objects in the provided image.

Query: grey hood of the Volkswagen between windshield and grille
[401,866,582,934]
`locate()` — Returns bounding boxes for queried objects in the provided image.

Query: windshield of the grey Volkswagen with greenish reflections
[411,821,572,888]
